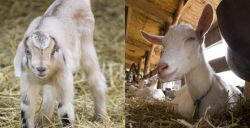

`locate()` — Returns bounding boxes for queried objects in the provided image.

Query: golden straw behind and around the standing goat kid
[0,0,125,128]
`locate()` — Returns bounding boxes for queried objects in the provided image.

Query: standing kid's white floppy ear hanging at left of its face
[13,39,27,77]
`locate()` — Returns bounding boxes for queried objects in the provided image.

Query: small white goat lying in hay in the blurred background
[129,76,165,101]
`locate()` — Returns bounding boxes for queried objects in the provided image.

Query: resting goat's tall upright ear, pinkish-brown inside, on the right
[196,4,213,38]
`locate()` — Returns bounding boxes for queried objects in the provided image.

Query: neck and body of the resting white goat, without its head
[173,59,241,119]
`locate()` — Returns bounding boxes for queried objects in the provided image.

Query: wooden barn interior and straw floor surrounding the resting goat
[125,0,249,127]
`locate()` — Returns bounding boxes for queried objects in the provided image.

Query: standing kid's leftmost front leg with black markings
[21,79,40,128]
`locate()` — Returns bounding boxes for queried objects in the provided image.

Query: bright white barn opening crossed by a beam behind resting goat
[204,40,245,86]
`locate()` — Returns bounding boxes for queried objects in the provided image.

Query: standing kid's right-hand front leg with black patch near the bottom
[57,71,75,127]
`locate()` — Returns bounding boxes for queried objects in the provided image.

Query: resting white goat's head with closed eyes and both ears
[141,5,213,81]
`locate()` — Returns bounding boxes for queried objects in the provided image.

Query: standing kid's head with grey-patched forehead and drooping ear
[14,31,62,79]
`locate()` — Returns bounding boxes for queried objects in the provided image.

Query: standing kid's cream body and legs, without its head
[18,0,106,127]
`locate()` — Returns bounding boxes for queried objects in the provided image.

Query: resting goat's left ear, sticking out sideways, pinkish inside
[141,31,163,45]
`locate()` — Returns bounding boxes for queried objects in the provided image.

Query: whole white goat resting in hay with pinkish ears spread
[142,5,241,118]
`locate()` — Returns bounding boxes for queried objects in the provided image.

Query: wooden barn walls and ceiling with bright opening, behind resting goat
[125,0,245,89]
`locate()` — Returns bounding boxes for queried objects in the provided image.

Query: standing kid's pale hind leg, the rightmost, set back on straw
[82,42,107,121]
